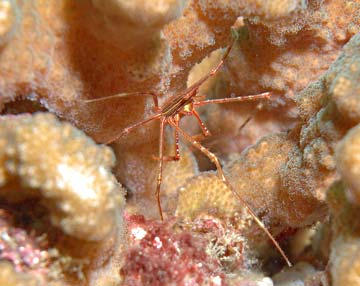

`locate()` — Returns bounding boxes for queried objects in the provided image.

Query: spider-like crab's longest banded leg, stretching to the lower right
[168,119,291,266]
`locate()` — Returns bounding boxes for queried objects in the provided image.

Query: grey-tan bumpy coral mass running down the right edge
[300,35,360,285]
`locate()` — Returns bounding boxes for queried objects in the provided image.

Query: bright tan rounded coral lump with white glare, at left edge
[0,114,124,241]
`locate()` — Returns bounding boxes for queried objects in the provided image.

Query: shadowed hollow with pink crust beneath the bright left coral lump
[0,183,96,285]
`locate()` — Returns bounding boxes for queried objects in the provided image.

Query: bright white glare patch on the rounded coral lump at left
[57,164,98,200]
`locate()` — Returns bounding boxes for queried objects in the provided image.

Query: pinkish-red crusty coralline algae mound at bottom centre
[121,215,228,286]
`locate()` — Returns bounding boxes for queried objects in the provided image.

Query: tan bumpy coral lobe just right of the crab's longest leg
[226,133,294,227]
